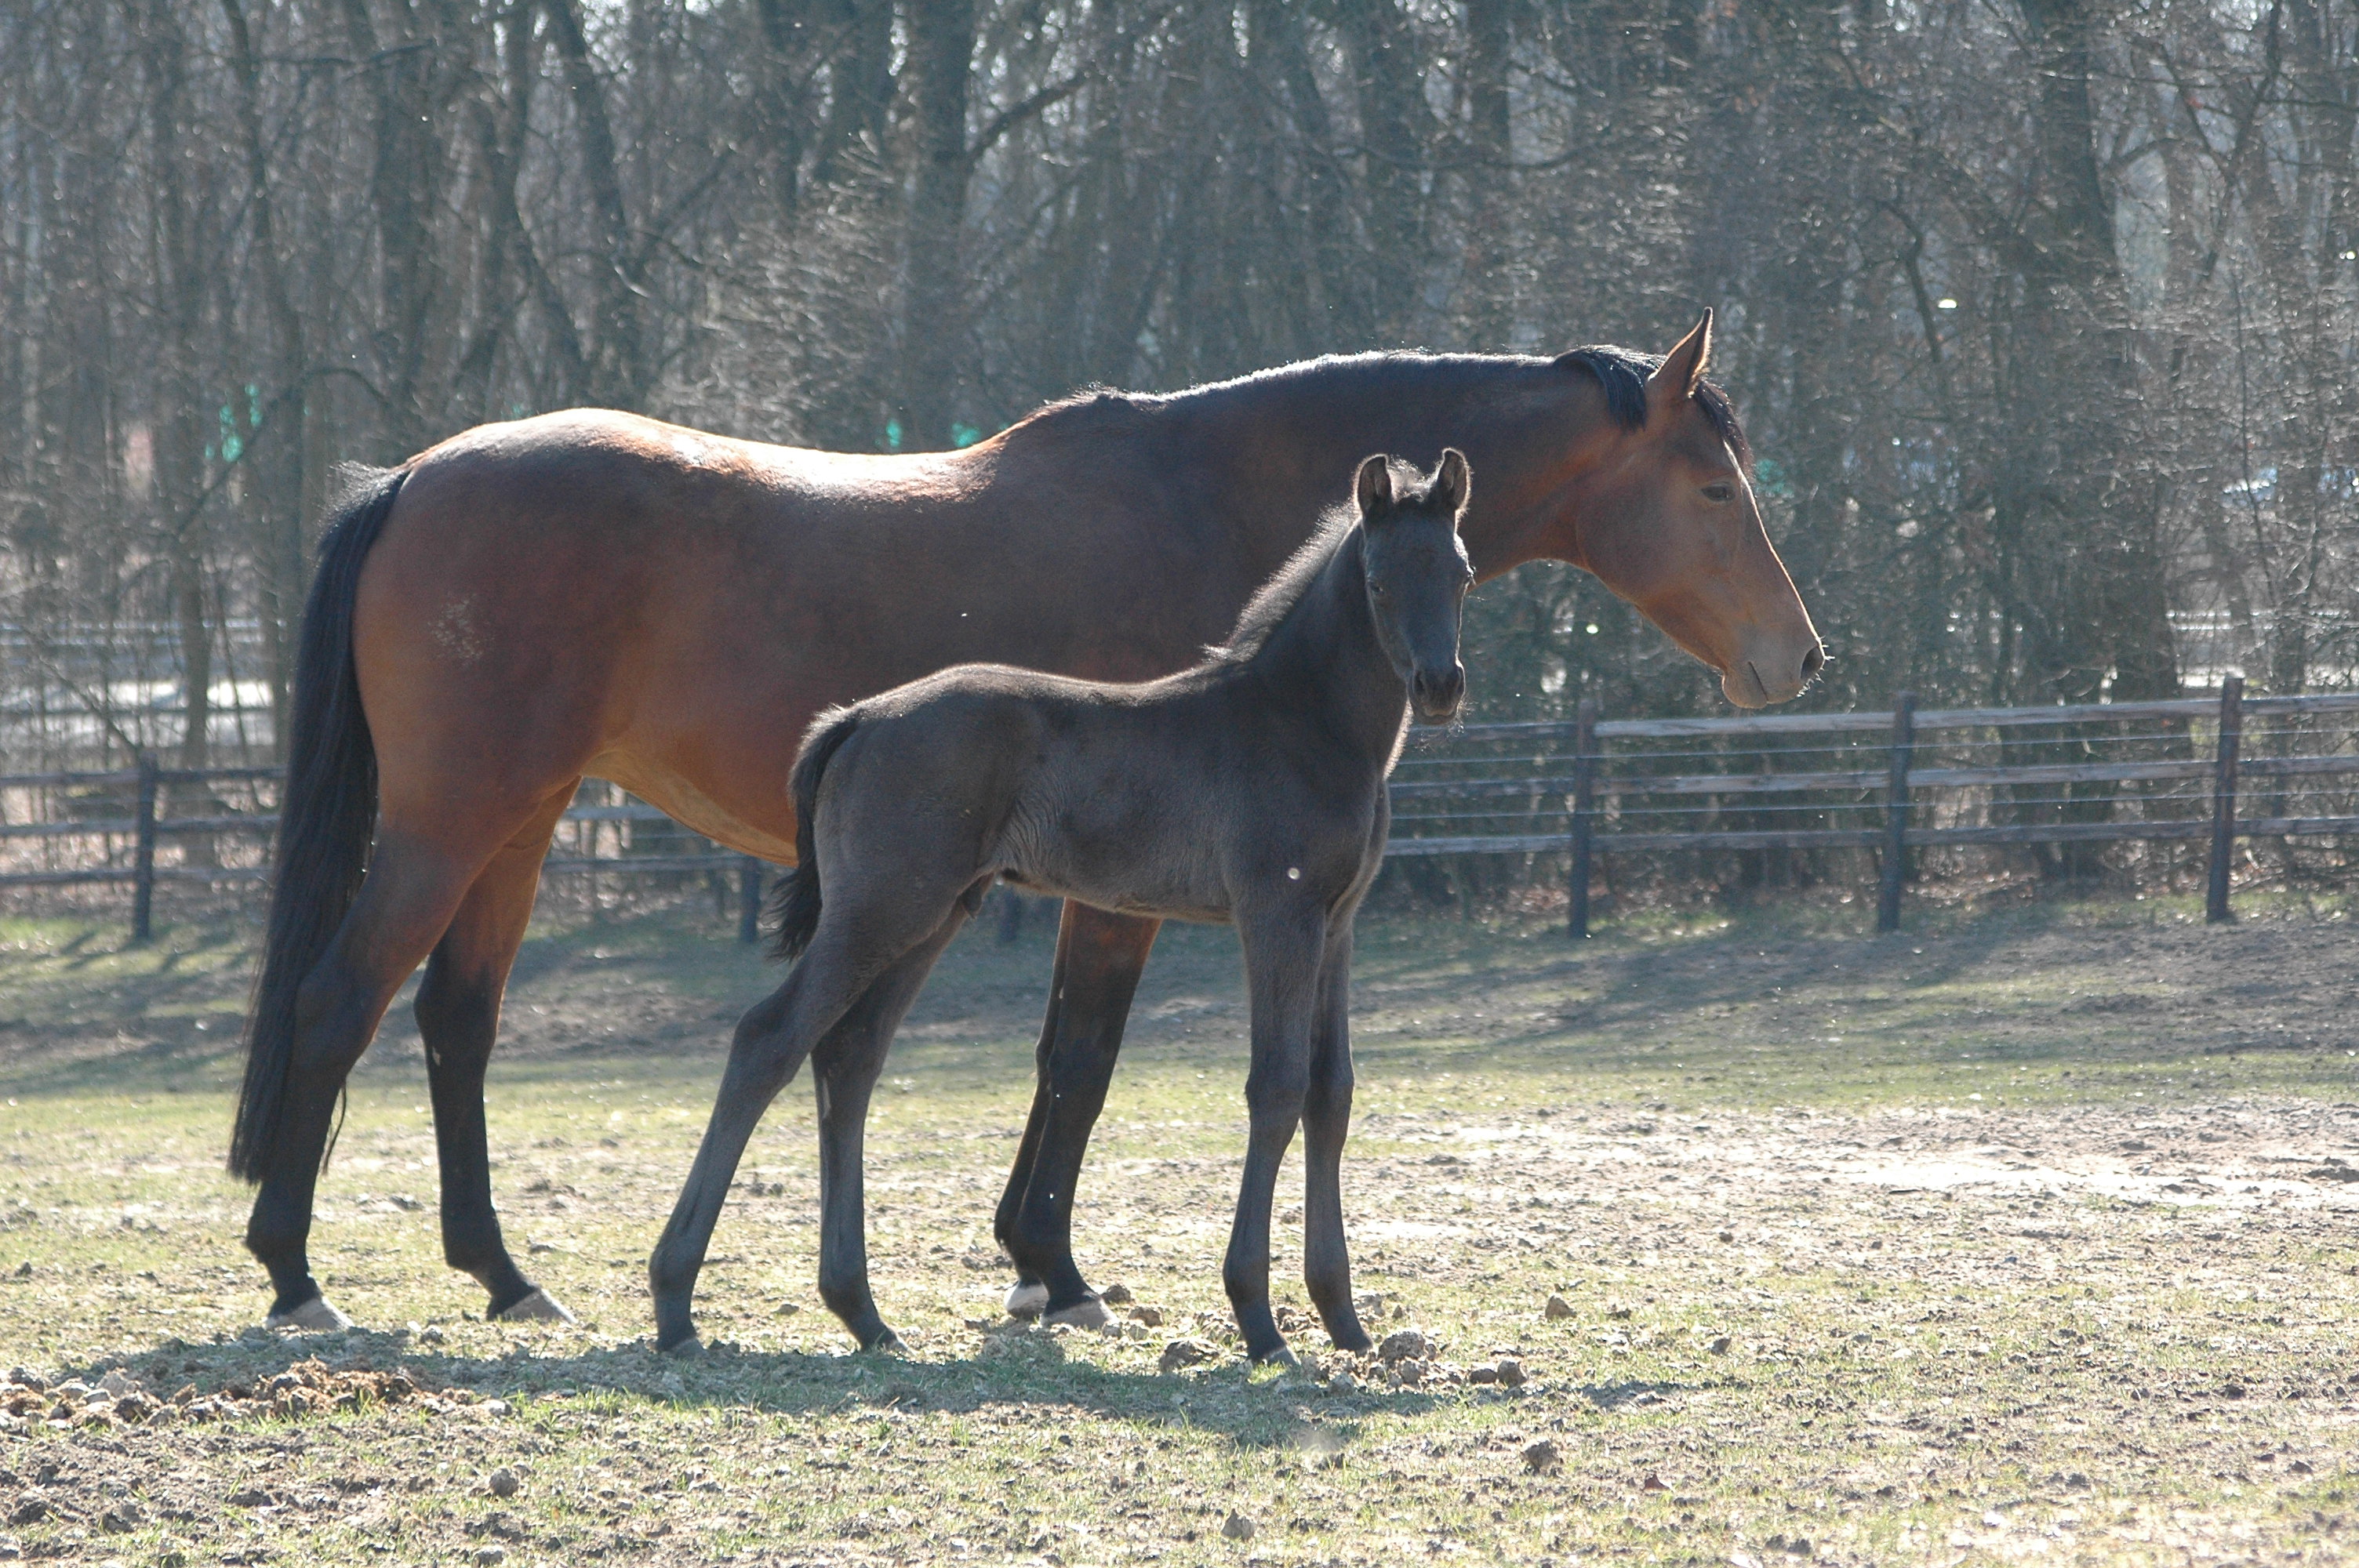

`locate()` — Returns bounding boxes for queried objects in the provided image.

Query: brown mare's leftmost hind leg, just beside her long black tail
[245,828,502,1327]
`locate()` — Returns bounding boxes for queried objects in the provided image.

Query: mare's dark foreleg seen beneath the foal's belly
[993,901,1163,1327]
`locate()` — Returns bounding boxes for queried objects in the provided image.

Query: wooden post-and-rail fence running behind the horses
[0,677,2359,941]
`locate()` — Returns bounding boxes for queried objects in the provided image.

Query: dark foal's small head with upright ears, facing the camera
[1352,448,1474,724]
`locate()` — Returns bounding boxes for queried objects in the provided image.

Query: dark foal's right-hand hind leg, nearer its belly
[812,906,967,1351]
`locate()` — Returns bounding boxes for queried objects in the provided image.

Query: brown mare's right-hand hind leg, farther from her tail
[415,786,573,1323]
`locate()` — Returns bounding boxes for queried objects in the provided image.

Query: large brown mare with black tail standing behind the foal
[231,316,1823,1325]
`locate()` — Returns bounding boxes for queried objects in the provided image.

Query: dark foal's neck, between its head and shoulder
[1248,528,1408,766]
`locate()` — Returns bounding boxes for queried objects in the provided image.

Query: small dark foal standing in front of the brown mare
[649,450,1474,1360]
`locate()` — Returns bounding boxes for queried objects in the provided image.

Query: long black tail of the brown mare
[229,464,408,1181]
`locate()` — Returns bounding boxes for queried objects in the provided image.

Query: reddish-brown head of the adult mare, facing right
[1533,311,1826,707]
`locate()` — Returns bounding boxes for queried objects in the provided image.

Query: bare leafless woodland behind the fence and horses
[0,0,2359,766]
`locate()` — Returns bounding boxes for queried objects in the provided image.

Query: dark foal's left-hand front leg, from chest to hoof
[1222,906,1329,1360]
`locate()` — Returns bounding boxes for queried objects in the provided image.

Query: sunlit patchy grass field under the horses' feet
[0,901,2359,1566]
